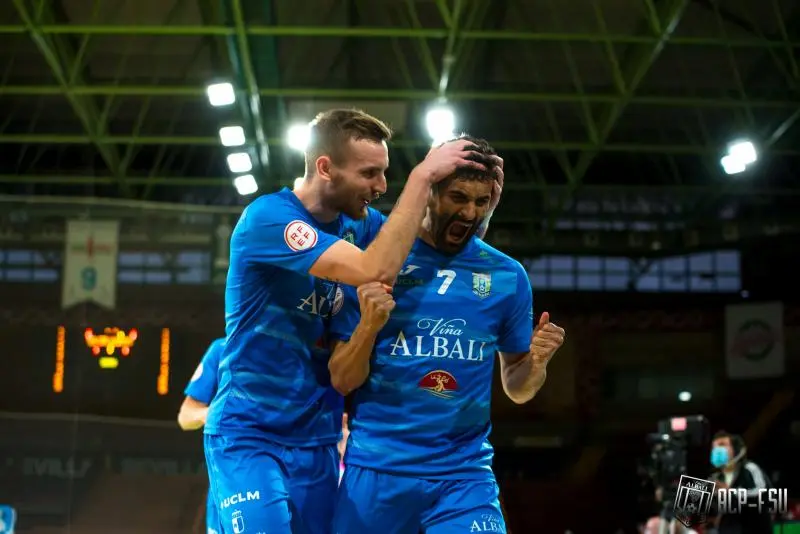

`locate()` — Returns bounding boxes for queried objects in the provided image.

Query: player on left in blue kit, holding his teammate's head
[204,110,490,534]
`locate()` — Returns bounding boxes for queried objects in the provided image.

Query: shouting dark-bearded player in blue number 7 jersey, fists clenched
[329,139,564,534]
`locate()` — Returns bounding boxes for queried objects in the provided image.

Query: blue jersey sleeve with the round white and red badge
[238,196,339,273]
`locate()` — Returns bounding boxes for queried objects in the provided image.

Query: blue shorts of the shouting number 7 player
[333,465,506,534]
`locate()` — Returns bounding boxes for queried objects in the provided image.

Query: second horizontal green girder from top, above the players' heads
[0,85,797,110]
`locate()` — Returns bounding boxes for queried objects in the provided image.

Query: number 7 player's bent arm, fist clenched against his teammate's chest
[328,282,395,395]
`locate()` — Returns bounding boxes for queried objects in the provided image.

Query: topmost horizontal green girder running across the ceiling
[0,24,800,49]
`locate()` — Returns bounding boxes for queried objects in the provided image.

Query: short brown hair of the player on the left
[306,109,392,177]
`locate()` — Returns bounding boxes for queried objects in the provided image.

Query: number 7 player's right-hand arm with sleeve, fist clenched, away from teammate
[498,267,564,404]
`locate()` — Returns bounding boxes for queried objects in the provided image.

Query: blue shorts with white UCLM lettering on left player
[204,435,339,534]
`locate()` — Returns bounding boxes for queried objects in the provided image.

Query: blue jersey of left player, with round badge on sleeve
[205,188,383,447]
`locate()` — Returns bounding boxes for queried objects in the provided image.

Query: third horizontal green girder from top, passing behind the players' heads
[0,134,800,156]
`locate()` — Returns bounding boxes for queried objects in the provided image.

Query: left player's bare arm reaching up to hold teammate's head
[309,140,494,286]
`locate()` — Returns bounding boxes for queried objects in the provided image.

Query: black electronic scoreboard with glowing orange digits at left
[0,324,212,419]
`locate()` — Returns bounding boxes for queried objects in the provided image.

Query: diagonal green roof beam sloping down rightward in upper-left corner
[13,0,130,195]
